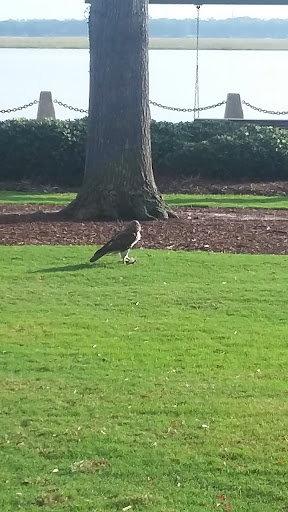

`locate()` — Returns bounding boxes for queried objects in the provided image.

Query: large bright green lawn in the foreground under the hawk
[0,246,288,512]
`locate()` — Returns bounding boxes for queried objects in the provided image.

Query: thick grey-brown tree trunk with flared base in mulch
[65,0,173,220]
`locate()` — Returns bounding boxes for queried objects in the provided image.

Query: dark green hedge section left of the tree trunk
[0,119,87,187]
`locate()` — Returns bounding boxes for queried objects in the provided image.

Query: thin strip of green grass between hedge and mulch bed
[0,190,288,209]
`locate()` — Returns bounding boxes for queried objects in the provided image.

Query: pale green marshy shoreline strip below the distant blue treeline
[0,37,288,51]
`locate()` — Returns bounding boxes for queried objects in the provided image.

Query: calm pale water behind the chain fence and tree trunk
[0,49,288,122]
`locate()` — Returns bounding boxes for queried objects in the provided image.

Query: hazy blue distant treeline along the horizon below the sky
[0,18,288,39]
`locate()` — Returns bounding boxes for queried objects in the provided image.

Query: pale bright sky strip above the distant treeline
[0,0,288,20]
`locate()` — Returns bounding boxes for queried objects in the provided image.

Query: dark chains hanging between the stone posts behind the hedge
[0,100,288,116]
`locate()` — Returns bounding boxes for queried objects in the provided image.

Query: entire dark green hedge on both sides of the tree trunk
[0,118,288,187]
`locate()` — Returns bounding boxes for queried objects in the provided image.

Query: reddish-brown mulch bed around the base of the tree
[0,205,288,254]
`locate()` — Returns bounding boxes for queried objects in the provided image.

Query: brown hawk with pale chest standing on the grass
[90,220,141,264]
